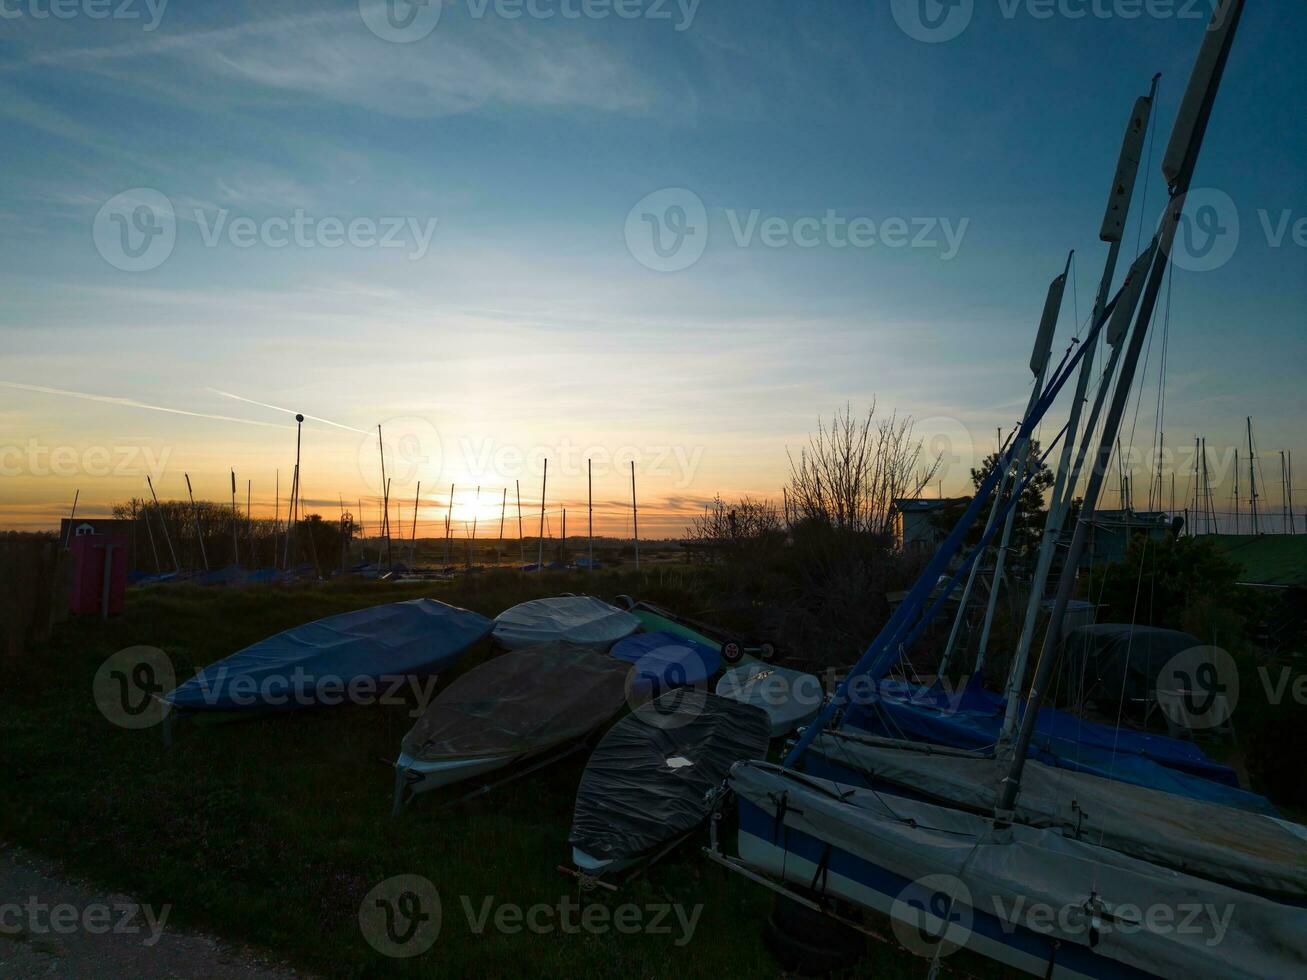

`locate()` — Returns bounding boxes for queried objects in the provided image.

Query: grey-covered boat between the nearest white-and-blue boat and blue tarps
[804,732,1307,904]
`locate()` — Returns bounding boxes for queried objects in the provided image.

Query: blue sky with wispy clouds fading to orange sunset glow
[0,0,1307,537]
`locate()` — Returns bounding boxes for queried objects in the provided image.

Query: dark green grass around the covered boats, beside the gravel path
[0,580,982,977]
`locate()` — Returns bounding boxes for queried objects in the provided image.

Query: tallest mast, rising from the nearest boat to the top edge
[996,0,1243,825]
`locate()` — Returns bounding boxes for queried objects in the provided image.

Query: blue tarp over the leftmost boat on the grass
[163,598,494,711]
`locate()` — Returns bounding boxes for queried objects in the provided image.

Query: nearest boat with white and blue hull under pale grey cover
[729,762,1307,980]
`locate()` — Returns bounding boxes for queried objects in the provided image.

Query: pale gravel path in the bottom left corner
[0,844,307,980]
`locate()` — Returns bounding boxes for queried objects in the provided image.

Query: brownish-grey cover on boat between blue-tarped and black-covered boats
[403,642,629,762]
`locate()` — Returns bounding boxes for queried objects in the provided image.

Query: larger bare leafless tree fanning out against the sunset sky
[786,402,940,534]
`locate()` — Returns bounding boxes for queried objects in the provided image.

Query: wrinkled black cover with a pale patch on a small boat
[569,689,771,861]
